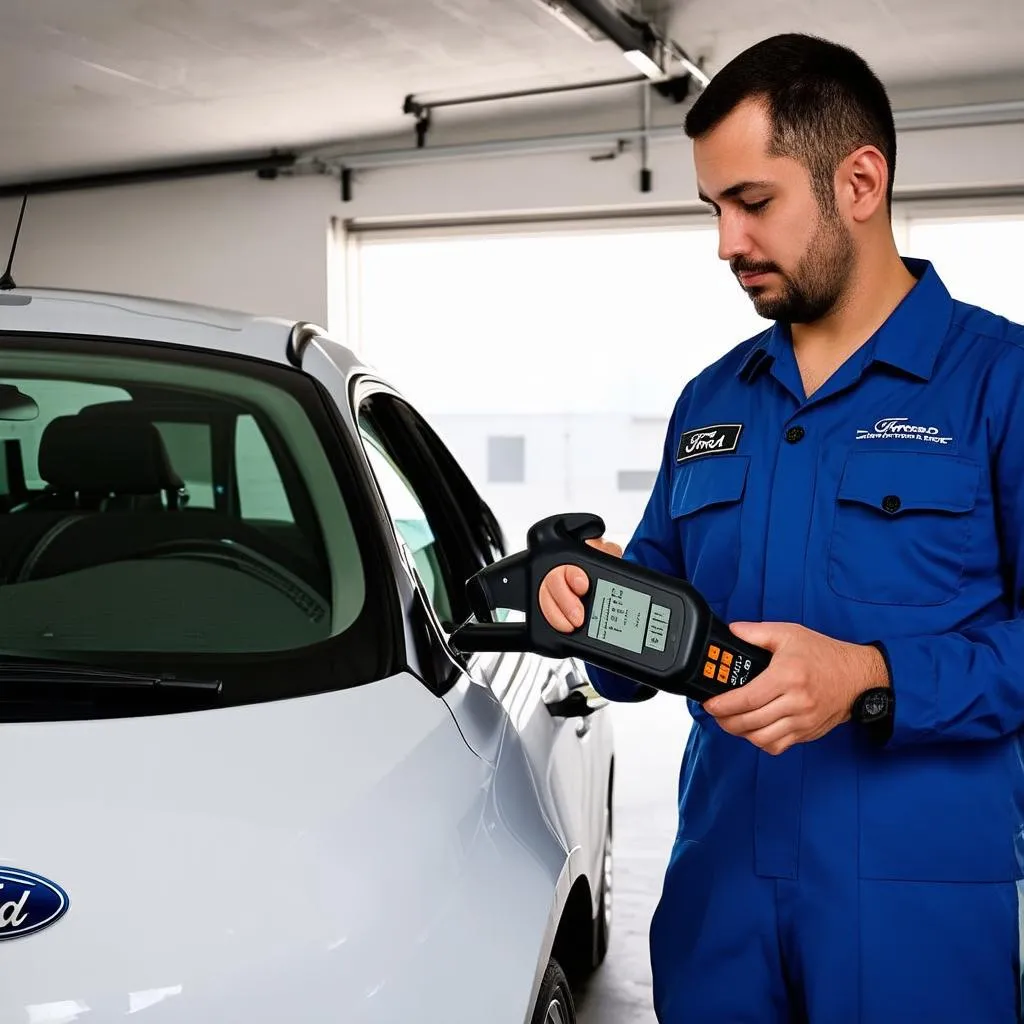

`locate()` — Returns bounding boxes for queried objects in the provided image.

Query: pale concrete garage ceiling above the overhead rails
[0,0,1024,181]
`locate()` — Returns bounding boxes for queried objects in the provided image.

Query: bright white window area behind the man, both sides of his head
[349,206,1024,547]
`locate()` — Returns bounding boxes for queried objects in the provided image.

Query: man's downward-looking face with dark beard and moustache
[693,101,855,324]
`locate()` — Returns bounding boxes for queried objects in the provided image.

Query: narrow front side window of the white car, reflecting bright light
[359,414,453,624]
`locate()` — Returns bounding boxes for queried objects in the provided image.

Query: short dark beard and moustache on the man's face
[729,204,855,324]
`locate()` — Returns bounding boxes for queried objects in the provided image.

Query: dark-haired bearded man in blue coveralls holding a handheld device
[540,35,1024,1024]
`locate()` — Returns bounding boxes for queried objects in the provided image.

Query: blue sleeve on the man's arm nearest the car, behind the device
[585,389,688,702]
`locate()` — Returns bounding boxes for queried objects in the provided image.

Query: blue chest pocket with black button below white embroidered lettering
[828,452,981,605]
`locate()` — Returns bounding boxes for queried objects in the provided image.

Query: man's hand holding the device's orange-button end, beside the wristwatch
[703,623,889,754]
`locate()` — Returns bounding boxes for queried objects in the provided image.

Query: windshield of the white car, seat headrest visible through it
[0,337,391,704]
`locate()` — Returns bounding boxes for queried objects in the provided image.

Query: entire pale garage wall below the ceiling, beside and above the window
[0,118,1024,326]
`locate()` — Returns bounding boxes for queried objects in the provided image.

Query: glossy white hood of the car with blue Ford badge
[0,676,528,1024]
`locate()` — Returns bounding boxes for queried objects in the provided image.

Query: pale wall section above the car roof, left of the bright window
[0,175,337,323]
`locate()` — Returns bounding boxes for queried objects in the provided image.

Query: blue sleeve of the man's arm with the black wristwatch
[874,351,1024,746]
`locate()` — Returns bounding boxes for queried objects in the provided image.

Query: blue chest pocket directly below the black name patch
[671,455,750,602]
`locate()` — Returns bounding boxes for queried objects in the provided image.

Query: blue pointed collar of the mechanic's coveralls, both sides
[736,258,953,382]
